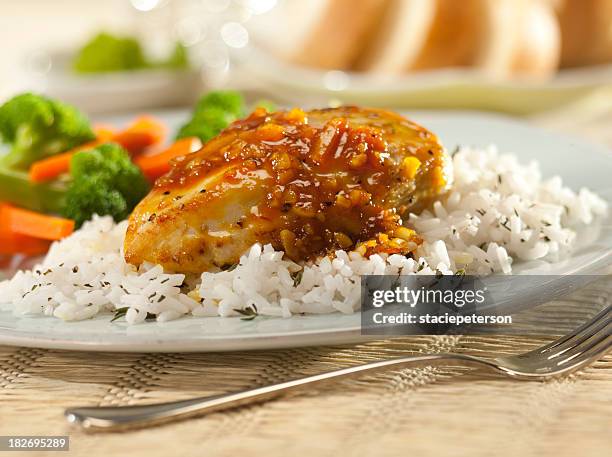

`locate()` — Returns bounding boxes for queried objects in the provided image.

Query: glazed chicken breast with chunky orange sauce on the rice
[124,107,450,273]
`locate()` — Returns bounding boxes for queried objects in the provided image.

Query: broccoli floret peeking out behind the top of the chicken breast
[176,91,244,143]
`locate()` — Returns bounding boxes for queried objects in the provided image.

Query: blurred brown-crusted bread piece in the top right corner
[559,0,612,67]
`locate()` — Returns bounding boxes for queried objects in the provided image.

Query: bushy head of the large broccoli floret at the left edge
[0,93,95,169]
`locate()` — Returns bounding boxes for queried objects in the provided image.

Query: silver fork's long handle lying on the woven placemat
[65,353,502,431]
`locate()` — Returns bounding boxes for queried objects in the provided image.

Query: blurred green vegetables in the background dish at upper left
[72,32,189,73]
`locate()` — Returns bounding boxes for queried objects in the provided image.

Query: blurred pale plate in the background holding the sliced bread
[235,45,612,114]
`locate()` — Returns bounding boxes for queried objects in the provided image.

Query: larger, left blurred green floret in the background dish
[72,32,148,73]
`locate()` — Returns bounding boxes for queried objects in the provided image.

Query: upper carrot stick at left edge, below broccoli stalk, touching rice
[0,203,74,241]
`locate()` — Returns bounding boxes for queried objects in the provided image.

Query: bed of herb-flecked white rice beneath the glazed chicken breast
[0,147,607,324]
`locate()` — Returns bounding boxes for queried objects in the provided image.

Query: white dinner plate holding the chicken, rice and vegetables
[0,112,612,352]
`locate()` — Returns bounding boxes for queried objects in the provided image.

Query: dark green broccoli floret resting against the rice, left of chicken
[62,143,149,227]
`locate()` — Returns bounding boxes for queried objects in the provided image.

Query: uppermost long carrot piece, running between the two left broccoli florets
[29,116,165,182]
